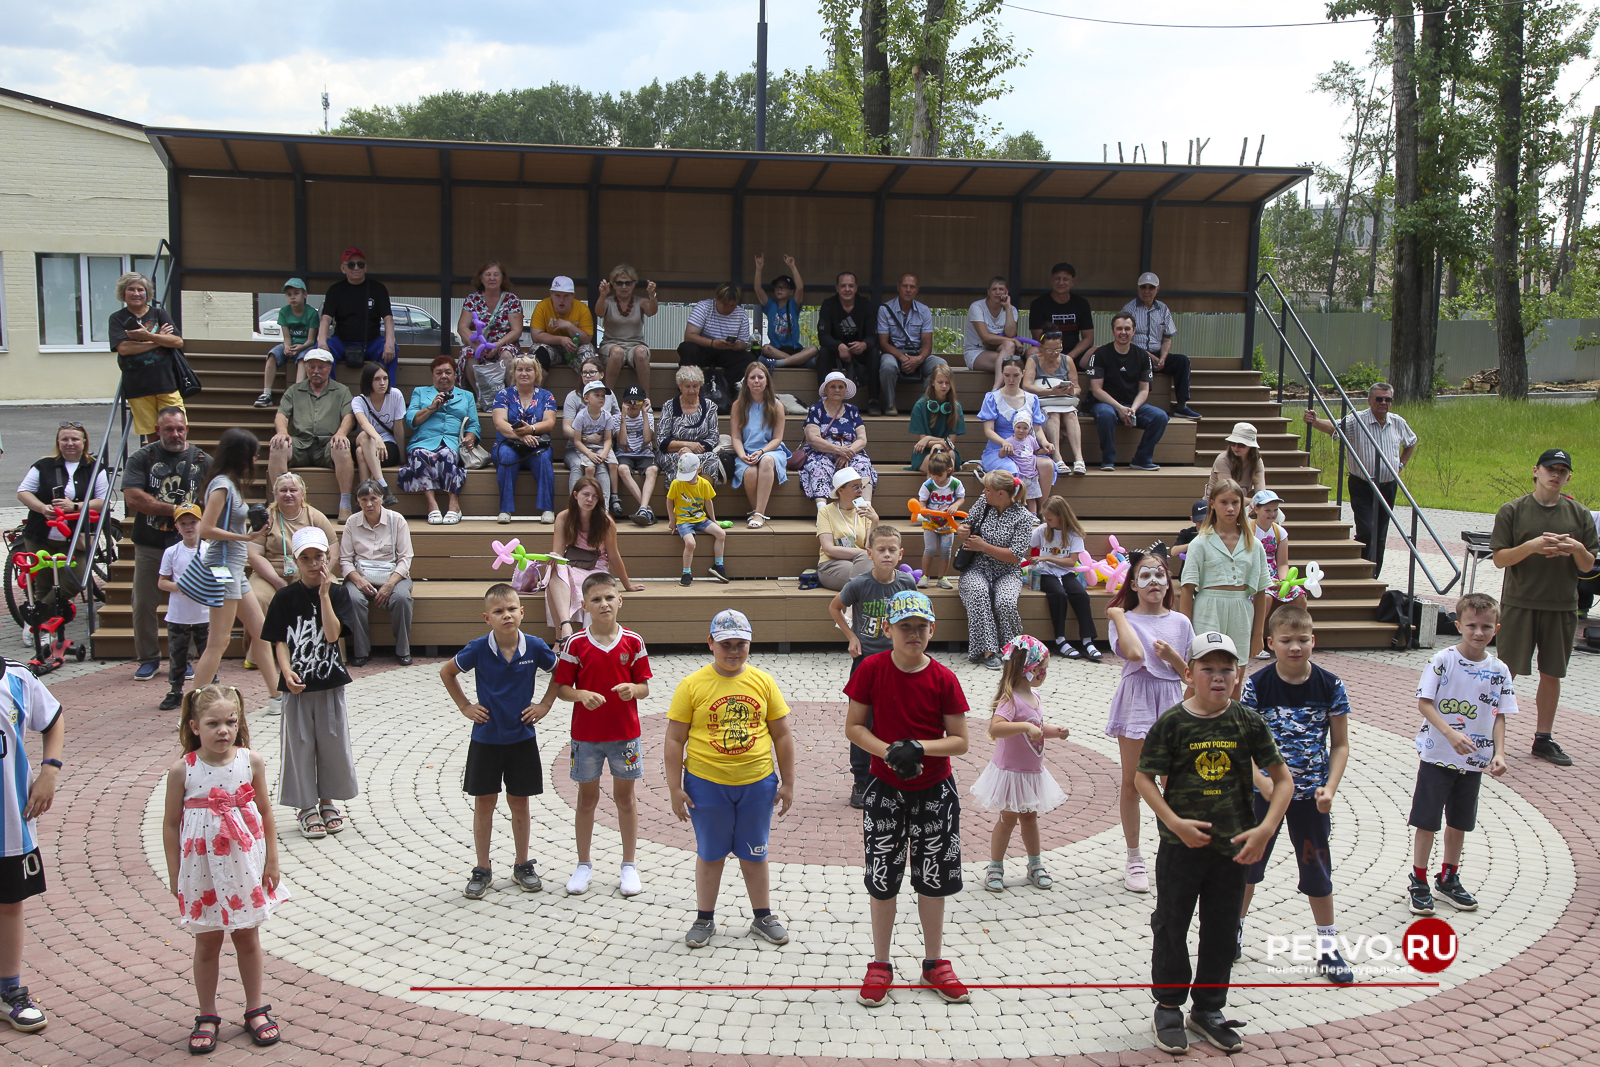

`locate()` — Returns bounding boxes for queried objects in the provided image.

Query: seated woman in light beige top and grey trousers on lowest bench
[339,478,413,667]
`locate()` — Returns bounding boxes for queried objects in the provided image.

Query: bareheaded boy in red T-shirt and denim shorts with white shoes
[555,571,650,896]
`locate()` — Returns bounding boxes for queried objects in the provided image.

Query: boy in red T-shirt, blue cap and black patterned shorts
[845,590,971,1008]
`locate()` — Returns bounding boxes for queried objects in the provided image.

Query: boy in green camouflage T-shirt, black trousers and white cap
[1134,632,1294,1053]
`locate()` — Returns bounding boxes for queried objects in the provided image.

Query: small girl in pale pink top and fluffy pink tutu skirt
[971,633,1067,893]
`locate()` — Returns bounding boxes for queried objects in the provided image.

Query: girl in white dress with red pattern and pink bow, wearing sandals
[162,685,290,1053]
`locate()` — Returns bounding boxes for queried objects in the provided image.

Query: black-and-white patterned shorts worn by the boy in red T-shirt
[861,776,962,901]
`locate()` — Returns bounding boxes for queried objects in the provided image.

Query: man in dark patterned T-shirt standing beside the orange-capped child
[122,406,211,681]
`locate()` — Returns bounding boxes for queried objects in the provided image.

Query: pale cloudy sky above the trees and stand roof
[9,0,1600,179]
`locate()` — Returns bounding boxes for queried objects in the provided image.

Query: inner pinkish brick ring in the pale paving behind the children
[546,701,1122,867]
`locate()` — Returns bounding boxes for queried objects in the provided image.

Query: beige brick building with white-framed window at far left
[0,88,251,400]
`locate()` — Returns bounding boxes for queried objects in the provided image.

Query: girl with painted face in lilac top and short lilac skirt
[1106,549,1195,893]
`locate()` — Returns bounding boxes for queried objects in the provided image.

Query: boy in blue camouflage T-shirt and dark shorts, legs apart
[1234,605,1355,985]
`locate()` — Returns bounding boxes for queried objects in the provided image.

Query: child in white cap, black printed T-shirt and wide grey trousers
[261,526,360,840]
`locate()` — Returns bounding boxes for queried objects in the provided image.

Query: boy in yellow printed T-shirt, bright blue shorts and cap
[664,608,795,949]
